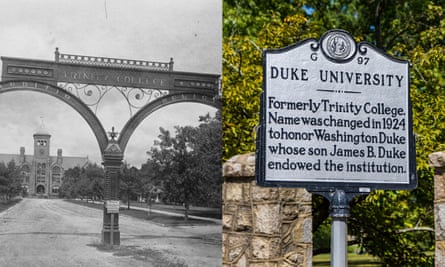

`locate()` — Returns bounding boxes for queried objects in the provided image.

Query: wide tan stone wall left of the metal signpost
[222,153,312,267]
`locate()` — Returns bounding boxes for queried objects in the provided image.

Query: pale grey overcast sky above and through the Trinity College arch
[0,0,222,167]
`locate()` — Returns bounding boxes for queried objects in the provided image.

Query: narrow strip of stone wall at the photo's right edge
[429,151,445,267]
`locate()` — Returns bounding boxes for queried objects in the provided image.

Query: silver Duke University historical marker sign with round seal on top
[257,30,417,192]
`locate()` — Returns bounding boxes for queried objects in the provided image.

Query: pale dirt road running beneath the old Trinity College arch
[0,199,221,267]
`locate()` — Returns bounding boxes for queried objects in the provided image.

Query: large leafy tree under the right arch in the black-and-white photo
[147,114,221,220]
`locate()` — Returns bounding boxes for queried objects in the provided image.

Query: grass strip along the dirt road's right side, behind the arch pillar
[65,199,219,226]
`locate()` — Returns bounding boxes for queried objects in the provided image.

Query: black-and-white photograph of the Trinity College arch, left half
[0,0,222,267]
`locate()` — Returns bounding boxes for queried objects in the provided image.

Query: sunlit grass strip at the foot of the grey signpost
[312,253,381,267]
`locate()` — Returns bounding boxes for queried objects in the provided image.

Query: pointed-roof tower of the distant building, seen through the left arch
[31,120,51,195]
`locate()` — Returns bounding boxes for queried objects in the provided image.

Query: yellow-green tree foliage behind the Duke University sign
[222,0,445,266]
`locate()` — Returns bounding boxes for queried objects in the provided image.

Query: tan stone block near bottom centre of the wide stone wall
[251,236,280,260]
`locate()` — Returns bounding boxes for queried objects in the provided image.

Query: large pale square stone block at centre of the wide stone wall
[253,203,281,234]
